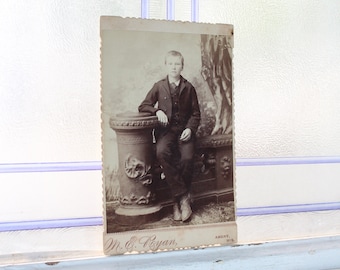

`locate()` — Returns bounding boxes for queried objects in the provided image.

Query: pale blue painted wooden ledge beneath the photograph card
[2,236,340,270]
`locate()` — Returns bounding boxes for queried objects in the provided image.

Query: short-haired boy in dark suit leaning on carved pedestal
[138,51,201,221]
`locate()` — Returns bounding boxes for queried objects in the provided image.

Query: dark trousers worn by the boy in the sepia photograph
[156,130,195,199]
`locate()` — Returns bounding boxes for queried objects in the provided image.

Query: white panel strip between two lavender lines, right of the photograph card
[236,163,340,208]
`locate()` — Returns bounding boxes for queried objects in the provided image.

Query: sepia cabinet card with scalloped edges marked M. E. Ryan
[100,16,237,255]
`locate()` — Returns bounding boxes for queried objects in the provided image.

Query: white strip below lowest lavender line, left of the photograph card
[0,226,103,266]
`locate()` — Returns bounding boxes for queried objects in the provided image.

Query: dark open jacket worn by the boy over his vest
[138,76,201,134]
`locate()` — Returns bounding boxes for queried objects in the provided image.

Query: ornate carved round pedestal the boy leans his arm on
[110,113,161,225]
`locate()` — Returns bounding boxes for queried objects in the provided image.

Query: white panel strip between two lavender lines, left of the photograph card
[0,171,102,223]
